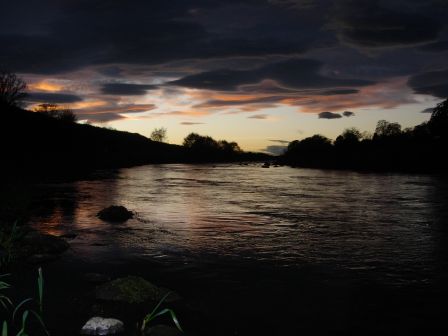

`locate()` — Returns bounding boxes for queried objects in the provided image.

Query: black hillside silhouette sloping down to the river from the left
[0,106,269,178]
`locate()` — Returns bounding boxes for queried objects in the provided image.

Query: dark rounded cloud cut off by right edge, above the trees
[408,69,448,98]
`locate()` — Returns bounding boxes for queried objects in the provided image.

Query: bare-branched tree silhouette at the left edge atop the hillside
[0,71,26,106]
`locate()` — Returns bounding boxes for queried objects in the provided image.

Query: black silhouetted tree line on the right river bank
[280,99,448,172]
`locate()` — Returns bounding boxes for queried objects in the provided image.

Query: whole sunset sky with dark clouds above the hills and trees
[0,0,448,153]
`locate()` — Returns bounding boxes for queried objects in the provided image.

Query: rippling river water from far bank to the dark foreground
[27,164,448,335]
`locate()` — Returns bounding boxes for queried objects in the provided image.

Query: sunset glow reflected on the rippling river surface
[28,165,448,284]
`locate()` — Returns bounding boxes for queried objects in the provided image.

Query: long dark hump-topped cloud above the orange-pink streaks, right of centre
[170,58,372,91]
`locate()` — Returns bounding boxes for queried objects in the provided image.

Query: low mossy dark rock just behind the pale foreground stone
[95,276,179,303]
